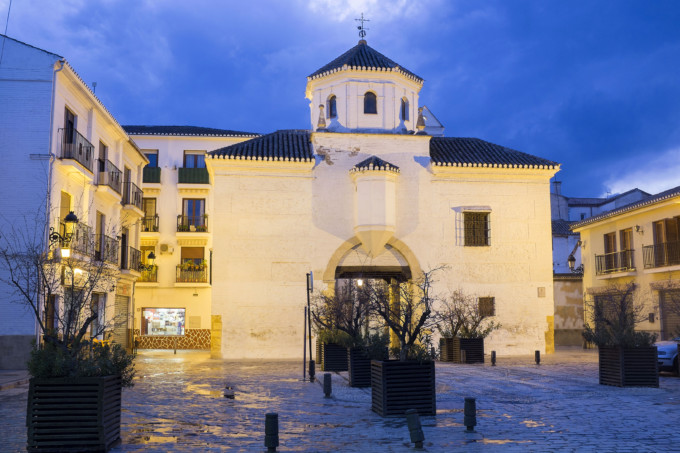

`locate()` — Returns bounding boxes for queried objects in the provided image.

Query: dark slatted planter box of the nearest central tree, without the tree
[371,360,437,417]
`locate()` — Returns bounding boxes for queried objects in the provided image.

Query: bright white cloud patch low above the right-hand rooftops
[603,146,680,195]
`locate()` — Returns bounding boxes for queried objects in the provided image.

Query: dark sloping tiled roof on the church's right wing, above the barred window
[430,137,559,169]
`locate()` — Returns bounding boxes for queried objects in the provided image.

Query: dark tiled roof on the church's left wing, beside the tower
[208,129,314,162]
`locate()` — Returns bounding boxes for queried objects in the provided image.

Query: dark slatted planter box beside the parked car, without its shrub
[599,346,659,387]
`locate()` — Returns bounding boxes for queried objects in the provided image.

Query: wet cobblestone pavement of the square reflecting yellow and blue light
[0,350,680,452]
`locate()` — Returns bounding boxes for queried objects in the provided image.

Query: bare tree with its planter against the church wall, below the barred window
[437,289,501,363]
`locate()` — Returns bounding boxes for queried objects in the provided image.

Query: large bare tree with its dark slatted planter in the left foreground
[0,216,134,451]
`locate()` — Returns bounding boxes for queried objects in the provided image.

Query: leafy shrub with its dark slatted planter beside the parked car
[583,283,659,387]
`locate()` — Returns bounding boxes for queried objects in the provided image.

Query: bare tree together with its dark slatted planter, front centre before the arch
[364,270,437,417]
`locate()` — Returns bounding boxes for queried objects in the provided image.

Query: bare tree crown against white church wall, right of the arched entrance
[436,289,501,338]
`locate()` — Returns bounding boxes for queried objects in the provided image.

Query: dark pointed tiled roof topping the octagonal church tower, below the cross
[307,39,423,83]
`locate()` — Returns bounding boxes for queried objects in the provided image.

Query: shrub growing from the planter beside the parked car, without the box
[583,283,656,348]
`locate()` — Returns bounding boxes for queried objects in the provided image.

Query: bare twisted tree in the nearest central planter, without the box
[363,268,441,361]
